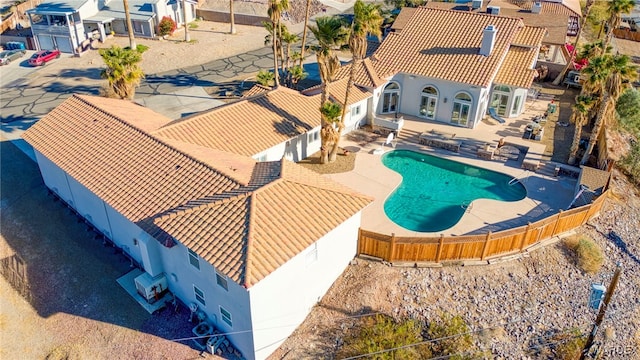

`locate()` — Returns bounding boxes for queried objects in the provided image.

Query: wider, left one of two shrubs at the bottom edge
[337,314,428,360]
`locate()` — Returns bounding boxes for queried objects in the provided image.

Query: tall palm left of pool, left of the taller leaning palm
[308,16,348,164]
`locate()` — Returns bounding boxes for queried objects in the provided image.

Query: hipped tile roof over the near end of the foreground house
[151,160,371,288]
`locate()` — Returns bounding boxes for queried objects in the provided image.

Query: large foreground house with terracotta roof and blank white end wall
[24,95,371,359]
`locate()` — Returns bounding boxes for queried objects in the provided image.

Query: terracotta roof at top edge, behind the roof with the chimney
[426,0,569,45]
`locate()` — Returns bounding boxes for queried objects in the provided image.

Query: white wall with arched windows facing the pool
[374,73,484,128]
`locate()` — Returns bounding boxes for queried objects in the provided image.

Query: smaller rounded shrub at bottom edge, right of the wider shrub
[426,313,484,360]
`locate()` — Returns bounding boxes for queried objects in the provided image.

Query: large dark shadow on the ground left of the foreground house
[0,141,202,352]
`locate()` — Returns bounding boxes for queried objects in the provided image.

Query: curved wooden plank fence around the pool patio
[358,190,609,263]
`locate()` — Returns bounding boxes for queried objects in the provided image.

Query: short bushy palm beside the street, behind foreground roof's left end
[99,45,144,99]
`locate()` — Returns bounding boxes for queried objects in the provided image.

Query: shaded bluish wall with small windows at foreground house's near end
[160,243,254,359]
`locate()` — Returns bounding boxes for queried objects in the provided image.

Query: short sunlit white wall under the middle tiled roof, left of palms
[253,126,321,162]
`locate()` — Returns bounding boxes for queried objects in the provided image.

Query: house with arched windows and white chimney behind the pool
[364,7,546,128]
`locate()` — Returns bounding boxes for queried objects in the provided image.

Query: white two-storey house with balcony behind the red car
[26,0,197,54]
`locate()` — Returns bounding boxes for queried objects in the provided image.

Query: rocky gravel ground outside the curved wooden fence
[271,170,640,360]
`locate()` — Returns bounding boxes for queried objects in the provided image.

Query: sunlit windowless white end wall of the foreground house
[245,212,361,359]
